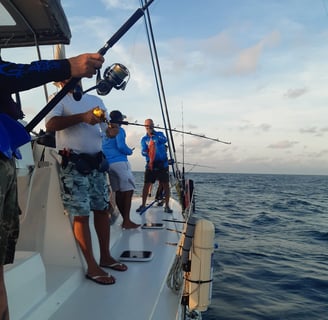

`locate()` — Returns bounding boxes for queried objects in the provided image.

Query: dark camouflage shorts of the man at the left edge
[0,154,20,265]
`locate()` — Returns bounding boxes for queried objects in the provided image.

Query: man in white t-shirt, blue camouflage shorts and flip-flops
[45,82,127,285]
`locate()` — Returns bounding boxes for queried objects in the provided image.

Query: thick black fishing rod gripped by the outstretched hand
[25,0,154,132]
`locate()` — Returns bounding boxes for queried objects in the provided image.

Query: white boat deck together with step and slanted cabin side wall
[5,145,183,320]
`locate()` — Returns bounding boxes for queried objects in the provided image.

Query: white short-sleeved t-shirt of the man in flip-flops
[45,93,107,154]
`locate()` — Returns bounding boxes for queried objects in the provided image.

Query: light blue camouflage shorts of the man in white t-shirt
[60,162,109,216]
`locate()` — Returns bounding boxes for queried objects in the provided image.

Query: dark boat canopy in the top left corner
[0,0,71,48]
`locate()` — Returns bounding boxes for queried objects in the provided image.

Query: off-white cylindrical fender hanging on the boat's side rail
[186,219,214,311]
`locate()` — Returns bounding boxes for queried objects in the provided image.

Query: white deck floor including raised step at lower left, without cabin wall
[5,197,183,320]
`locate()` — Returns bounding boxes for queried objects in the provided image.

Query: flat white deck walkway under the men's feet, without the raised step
[50,198,182,320]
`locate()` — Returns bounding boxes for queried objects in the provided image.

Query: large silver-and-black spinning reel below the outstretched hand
[73,63,130,101]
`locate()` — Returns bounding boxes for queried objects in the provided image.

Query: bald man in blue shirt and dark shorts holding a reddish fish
[137,119,173,213]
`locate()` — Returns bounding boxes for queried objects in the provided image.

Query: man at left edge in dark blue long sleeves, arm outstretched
[0,53,104,319]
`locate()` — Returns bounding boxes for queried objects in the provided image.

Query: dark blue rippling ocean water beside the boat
[136,173,328,320]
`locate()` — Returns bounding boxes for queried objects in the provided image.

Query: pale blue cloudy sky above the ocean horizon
[1,0,328,175]
